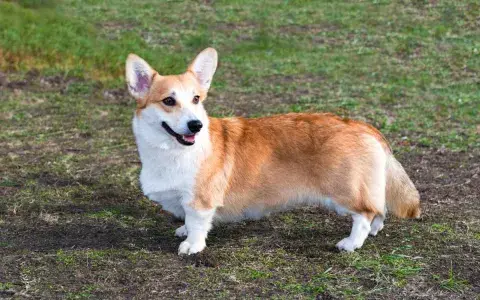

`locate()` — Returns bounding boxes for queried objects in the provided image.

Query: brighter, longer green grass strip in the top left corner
[0,2,186,80]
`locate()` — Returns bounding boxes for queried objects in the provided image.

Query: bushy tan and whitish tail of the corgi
[385,155,420,218]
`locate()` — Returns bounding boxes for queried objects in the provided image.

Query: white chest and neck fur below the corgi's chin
[133,116,210,218]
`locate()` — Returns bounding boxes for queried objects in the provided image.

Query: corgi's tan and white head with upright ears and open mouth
[126,48,217,146]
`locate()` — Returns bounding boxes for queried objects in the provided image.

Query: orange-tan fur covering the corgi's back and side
[188,114,418,220]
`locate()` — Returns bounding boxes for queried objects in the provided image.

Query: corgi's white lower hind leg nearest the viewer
[337,213,373,252]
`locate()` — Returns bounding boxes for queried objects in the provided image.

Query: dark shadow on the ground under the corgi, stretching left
[0,196,351,266]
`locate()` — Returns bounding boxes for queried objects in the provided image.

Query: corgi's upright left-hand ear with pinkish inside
[125,54,157,102]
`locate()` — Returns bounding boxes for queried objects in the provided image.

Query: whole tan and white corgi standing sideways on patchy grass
[126,48,420,255]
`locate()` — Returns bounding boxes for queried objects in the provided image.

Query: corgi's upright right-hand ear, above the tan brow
[188,48,218,91]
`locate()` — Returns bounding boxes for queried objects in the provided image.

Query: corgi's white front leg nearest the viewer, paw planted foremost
[178,204,215,255]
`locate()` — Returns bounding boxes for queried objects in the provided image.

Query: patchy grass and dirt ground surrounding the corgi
[0,0,480,299]
